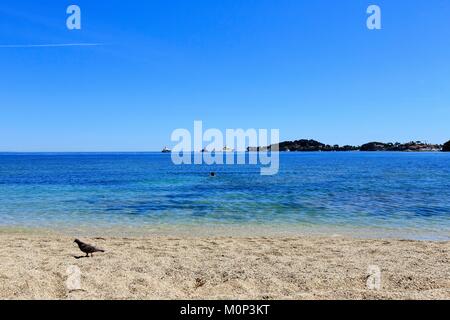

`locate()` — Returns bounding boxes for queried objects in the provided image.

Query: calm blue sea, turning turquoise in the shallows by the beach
[0,152,450,240]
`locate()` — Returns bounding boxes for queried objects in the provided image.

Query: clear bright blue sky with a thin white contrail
[0,0,450,152]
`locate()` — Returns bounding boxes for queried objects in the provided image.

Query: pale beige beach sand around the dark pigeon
[0,232,450,299]
